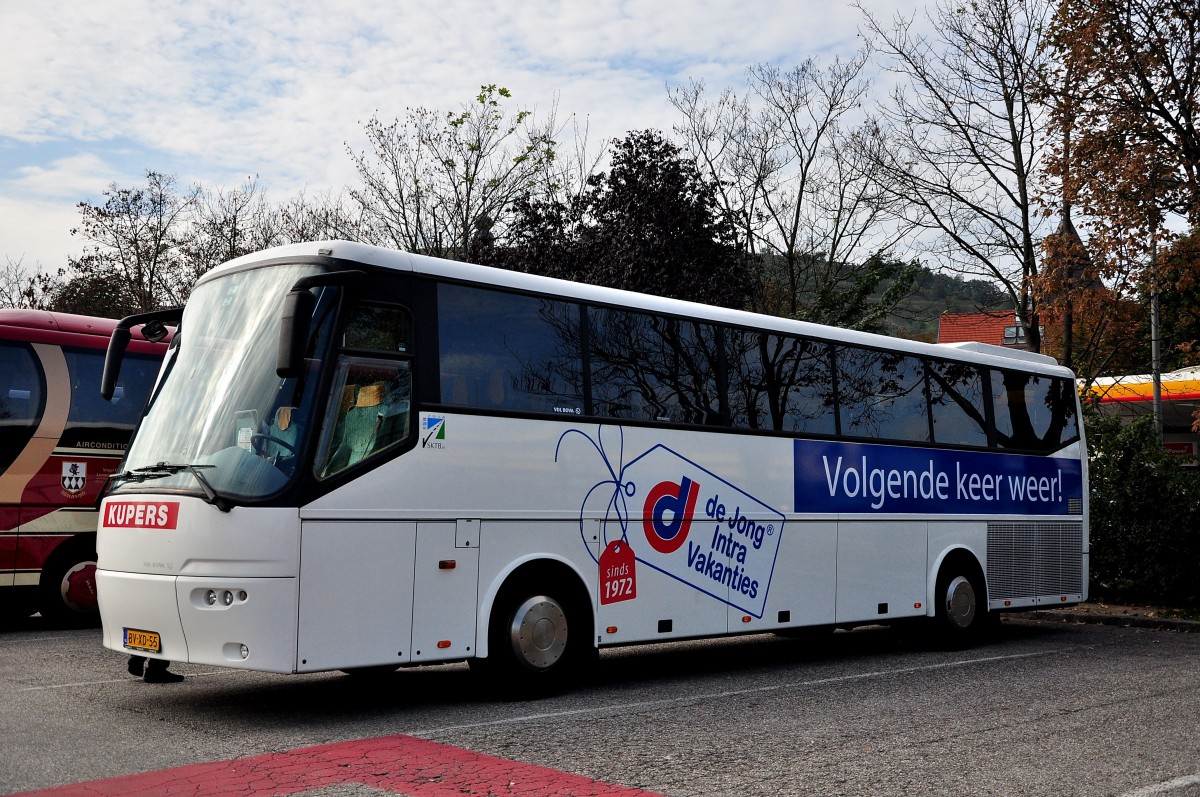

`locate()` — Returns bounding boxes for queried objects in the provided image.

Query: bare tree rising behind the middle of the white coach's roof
[668,50,902,318]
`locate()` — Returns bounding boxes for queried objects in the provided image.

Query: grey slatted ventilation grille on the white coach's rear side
[988,523,1084,600]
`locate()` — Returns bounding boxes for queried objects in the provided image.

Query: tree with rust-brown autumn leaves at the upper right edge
[1042,0,1200,384]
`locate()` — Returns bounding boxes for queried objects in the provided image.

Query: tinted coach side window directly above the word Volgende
[836,346,929,442]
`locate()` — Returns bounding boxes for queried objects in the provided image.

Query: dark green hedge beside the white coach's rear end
[1085,407,1200,609]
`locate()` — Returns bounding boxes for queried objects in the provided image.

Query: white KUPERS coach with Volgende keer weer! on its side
[97,241,1088,687]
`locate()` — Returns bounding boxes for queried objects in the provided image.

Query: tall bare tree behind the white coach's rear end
[857,0,1050,350]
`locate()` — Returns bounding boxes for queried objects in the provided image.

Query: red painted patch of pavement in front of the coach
[14,736,659,797]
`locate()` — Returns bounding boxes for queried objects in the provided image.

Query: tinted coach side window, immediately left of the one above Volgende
[726,329,835,435]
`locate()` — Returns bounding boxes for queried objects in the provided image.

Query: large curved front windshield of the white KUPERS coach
[113,264,332,501]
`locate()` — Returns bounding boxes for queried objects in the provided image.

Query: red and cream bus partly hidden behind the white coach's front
[0,310,167,624]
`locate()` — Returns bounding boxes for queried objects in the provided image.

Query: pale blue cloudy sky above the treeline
[0,0,924,270]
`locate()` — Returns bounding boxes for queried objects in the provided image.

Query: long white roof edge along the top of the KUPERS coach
[211,240,1074,378]
